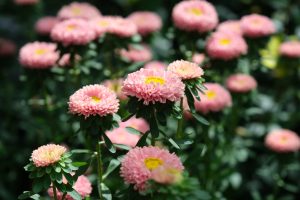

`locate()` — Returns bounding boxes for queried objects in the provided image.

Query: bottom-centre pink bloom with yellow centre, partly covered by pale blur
[120,146,184,191]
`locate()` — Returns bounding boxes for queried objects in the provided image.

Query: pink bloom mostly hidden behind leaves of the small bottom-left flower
[48,175,92,200]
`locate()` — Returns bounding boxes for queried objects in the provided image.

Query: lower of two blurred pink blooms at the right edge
[265,129,300,153]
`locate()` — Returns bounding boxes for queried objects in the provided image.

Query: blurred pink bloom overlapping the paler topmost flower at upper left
[51,19,96,45]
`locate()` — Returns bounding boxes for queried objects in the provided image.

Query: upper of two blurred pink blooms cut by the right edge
[280,41,300,58]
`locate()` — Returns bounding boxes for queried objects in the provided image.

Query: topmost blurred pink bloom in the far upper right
[241,14,276,38]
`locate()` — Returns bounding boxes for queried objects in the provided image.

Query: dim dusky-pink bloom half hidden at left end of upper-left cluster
[35,16,59,35]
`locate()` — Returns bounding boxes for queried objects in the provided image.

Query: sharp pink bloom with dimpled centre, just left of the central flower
[69,84,119,118]
